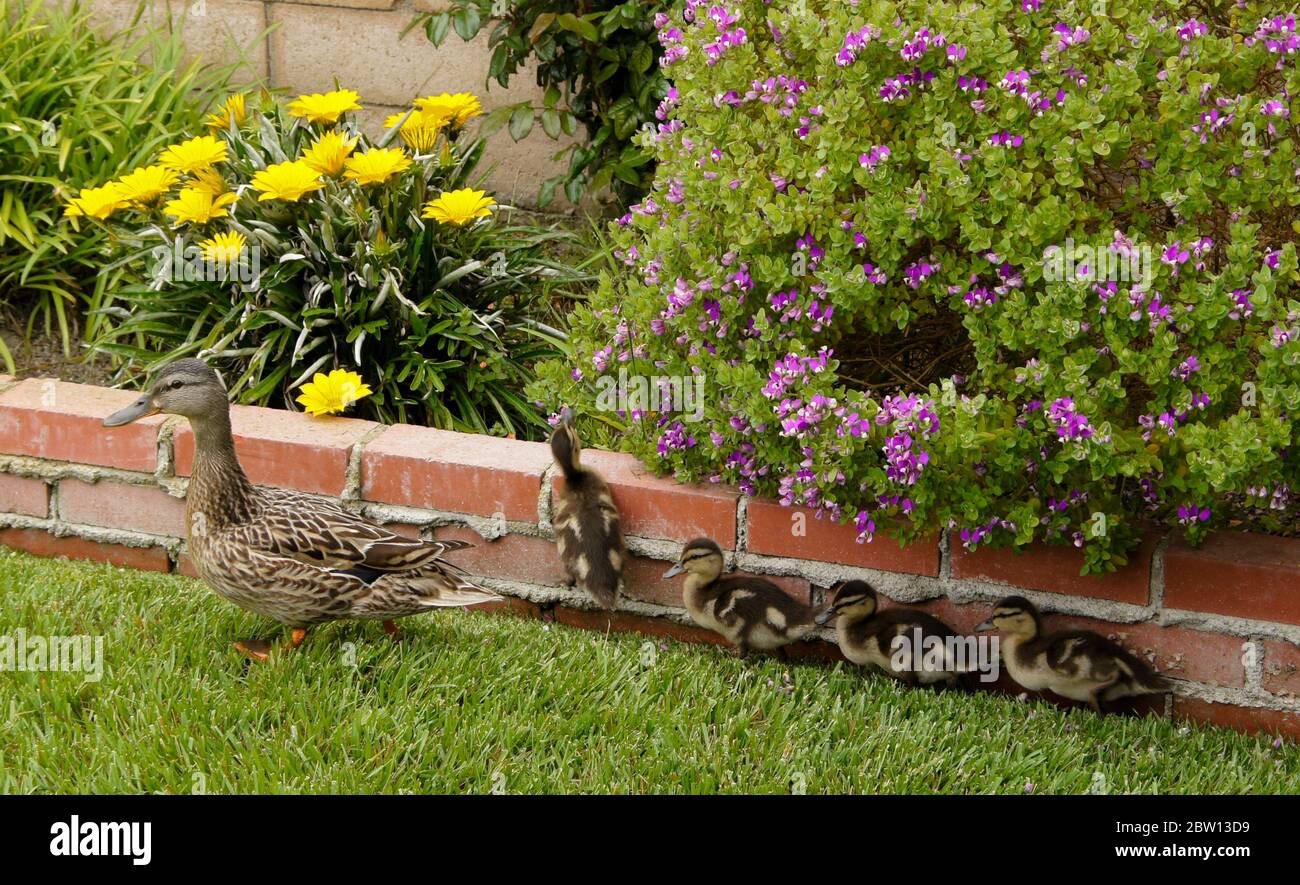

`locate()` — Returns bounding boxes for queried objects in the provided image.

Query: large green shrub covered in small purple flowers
[534,0,1300,572]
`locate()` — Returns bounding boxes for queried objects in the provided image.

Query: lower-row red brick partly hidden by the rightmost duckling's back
[1045,615,1245,689]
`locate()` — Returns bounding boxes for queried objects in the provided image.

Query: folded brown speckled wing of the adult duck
[226,489,473,572]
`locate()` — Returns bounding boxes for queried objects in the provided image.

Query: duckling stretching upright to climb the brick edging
[551,409,628,608]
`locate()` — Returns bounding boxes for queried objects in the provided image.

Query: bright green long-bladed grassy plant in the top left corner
[0,0,233,372]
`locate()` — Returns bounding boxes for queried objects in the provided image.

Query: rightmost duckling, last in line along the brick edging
[975,596,1170,713]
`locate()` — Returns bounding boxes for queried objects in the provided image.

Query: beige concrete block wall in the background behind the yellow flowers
[76,0,572,209]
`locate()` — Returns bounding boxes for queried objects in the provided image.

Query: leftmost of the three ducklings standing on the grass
[663,538,815,658]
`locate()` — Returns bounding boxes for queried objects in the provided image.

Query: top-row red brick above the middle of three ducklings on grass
[745,499,939,577]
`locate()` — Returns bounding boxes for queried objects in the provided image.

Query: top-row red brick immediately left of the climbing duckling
[361,424,551,522]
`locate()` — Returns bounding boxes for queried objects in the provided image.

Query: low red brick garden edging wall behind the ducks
[0,377,1300,737]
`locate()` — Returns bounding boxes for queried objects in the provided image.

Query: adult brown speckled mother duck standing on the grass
[104,359,499,660]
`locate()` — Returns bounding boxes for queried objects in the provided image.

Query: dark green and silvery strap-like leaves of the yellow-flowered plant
[94,94,580,438]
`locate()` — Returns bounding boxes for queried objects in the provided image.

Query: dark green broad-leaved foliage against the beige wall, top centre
[416,0,672,205]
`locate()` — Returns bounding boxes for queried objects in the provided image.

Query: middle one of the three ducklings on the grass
[816,581,961,686]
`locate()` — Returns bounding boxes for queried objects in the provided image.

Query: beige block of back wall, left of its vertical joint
[167,0,269,84]
